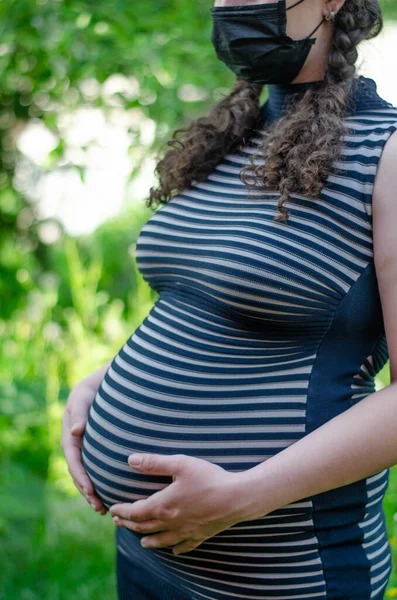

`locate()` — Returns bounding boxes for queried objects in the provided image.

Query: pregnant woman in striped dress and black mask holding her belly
[62,0,397,600]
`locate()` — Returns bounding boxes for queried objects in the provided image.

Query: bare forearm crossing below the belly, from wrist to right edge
[236,381,397,520]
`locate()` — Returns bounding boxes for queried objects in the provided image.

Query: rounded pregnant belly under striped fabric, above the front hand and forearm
[82,301,309,507]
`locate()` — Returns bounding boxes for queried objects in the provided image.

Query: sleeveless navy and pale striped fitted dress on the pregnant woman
[82,76,397,600]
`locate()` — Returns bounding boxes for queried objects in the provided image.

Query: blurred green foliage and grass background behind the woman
[0,0,397,600]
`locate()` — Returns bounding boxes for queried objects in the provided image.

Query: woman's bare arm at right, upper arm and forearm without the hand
[234,132,397,518]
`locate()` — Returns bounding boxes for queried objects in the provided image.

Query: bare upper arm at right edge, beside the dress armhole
[372,131,397,381]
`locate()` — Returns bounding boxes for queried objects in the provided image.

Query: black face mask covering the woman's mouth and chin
[210,0,325,84]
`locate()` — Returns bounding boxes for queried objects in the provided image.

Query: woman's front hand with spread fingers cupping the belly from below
[109,454,250,554]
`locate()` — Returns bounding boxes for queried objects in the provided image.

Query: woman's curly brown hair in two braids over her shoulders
[147,0,383,221]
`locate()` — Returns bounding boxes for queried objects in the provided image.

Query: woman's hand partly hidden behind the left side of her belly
[61,361,111,515]
